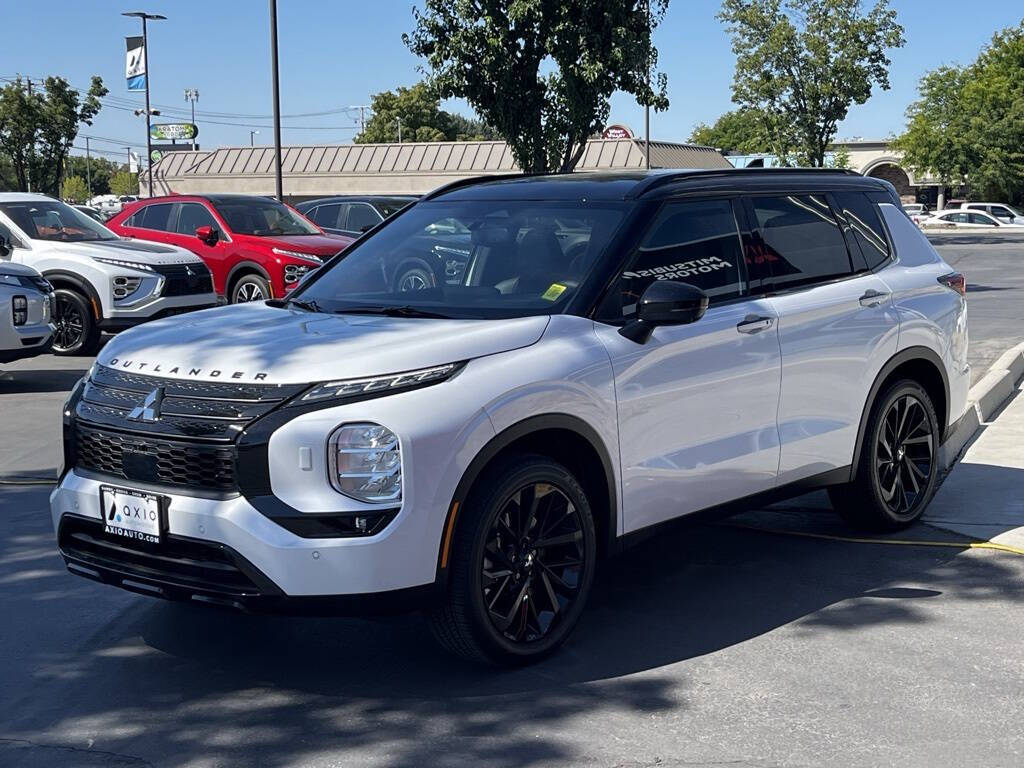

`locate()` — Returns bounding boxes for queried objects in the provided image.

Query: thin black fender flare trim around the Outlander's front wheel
[436,414,618,583]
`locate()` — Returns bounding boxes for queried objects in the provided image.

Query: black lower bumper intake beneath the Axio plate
[57,515,279,599]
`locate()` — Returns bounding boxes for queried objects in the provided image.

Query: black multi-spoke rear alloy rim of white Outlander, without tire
[874,394,935,517]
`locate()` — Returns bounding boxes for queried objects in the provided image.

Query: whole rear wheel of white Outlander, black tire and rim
[828,379,939,531]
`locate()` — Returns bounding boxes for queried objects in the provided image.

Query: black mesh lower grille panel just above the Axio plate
[75,424,236,492]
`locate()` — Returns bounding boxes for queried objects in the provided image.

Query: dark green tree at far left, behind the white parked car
[0,77,106,195]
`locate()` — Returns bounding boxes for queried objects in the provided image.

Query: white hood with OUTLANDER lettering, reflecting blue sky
[96,302,549,384]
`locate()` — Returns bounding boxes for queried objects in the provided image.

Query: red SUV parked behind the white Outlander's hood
[106,195,352,304]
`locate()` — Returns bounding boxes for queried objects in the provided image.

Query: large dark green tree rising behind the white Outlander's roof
[402,0,669,173]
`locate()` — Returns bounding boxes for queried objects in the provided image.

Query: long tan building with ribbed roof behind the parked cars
[141,138,731,202]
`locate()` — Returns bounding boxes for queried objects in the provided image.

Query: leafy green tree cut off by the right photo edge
[896,22,1024,202]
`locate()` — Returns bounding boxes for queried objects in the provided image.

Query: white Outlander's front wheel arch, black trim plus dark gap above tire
[437,414,618,582]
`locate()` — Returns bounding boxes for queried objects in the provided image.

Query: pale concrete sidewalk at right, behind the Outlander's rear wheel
[923,376,1024,549]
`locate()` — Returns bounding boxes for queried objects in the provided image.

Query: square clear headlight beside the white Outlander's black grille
[328,424,401,504]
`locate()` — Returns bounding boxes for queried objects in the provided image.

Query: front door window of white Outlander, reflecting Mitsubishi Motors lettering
[600,200,745,321]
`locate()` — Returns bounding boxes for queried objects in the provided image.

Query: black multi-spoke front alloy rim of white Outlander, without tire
[480,482,586,643]
